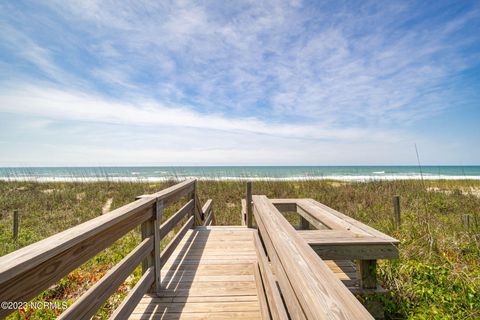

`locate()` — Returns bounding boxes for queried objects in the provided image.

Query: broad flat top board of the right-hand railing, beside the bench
[253,196,372,319]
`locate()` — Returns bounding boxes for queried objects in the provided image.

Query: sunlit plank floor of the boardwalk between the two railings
[130,227,261,320]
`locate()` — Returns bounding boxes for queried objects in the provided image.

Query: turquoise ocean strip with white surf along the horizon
[0,166,480,182]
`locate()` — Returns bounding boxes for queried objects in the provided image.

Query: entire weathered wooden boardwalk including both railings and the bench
[0,180,398,319]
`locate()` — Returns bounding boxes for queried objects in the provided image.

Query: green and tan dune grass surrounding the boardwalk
[0,180,480,319]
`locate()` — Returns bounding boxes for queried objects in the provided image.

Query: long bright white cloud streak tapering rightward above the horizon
[0,84,396,141]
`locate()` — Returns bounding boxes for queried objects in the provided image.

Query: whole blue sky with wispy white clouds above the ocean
[0,0,480,166]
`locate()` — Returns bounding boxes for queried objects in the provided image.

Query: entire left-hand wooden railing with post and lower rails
[0,180,214,319]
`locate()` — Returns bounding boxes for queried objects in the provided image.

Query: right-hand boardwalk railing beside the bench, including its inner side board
[253,196,373,319]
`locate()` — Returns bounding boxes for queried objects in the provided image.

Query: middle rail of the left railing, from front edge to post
[59,238,153,319]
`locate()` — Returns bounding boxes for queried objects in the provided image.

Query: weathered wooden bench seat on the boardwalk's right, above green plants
[271,199,399,292]
